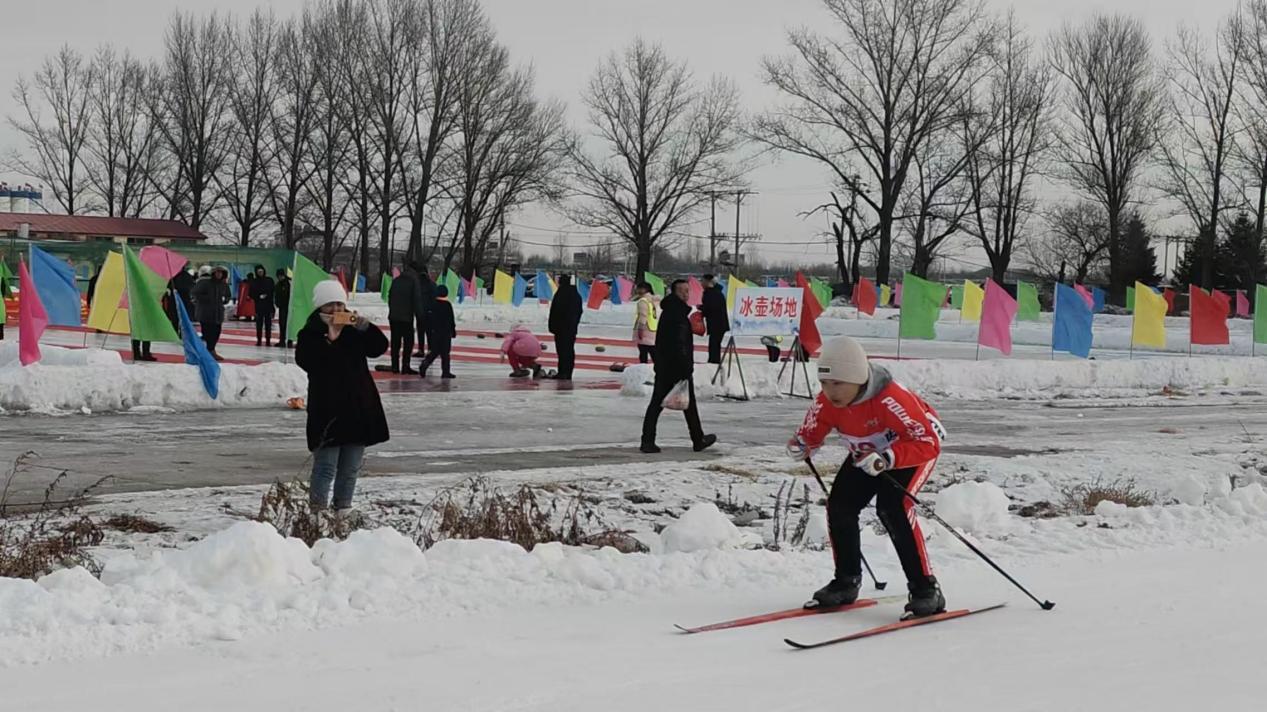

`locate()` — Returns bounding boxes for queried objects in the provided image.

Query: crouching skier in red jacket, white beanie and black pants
[788,337,945,616]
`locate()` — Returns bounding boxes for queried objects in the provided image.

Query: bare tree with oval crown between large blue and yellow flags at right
[1052,15,1166,293]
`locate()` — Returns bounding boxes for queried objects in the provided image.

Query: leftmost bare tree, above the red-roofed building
[9,46,92,215]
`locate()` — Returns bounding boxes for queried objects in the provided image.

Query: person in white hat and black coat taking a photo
[295,280,390,517]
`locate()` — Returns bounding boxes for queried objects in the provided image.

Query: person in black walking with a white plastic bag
[641,280,717,455]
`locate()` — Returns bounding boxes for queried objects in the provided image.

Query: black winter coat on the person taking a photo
[295,312,390,451]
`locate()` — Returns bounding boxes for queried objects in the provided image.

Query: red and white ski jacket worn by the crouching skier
[796,365,945,470]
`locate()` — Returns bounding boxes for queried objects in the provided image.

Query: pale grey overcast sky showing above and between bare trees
[0,0,1237,264]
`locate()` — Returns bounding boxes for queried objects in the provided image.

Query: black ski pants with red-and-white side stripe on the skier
[827,460,936,589]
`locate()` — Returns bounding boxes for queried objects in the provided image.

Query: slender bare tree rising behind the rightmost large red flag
[1158,15,1247,289]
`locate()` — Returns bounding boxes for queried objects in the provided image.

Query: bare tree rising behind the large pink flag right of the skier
[963,13,1053,284]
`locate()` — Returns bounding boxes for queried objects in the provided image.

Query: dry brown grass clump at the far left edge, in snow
[0,452,109,579]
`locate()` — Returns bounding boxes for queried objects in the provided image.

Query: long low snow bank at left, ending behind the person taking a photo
[0,347,308,413]
